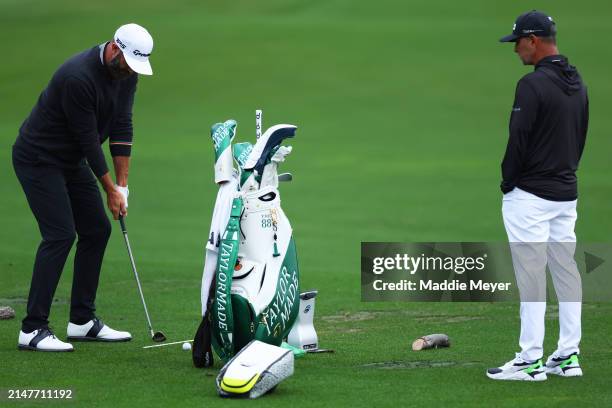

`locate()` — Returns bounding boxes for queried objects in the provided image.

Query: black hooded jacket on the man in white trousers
[501,55,589,201]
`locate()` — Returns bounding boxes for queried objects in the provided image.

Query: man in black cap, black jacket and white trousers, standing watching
[487,10,589,381]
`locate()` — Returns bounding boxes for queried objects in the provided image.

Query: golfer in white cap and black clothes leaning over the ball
[13,24,153,351]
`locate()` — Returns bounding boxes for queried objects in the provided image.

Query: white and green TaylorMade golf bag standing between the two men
[193,121,300,367]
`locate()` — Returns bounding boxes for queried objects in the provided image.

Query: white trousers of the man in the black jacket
[502,188,582,361]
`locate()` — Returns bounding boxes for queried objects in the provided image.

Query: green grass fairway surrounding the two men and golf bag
[0,0,612,407]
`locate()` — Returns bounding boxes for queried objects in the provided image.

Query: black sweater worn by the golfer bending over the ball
[14,45,138,177]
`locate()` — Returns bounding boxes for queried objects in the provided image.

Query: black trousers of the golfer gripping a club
[13,159,111,332]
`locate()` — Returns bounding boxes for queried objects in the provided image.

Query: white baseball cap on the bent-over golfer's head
[114,24,153,75]
